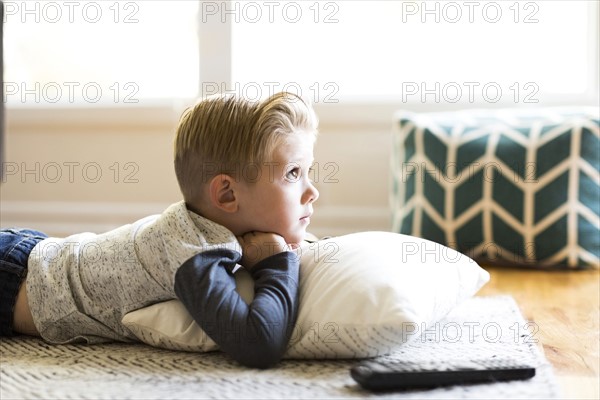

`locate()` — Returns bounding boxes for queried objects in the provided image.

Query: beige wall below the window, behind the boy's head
[0,107,392,236]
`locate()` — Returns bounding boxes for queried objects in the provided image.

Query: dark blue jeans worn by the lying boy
[0,229,48,336]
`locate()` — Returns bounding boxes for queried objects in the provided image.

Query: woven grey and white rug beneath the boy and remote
[0,296,559,400]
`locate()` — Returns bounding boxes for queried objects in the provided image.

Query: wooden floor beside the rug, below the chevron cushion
[478,267,600,399]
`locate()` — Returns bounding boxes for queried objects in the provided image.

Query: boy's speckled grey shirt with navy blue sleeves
[27,201,299,367]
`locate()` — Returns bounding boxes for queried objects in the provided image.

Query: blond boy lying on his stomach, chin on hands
[0,93,319,368]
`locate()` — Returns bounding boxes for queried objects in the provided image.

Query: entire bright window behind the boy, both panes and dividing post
[5,0,599,108]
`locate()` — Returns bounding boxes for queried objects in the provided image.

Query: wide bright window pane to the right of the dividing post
[232,0,596,103]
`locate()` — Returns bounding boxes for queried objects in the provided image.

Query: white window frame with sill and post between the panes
[6,0,600,128]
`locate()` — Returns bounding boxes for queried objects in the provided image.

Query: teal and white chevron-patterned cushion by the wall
[391,107,600,269]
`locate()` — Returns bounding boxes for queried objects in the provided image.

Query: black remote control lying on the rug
[350,357,535,391]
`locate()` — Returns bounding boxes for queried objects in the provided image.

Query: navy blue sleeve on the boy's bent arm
[175,249,299,368]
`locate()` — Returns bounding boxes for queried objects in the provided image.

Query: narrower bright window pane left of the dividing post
[4,1,199,106]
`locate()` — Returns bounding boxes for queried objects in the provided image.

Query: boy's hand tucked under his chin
[237,232,290,269]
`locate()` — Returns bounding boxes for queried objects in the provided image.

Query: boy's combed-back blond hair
[175,92,318,206]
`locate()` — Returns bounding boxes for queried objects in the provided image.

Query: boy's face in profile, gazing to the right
[238,133,319,243]
